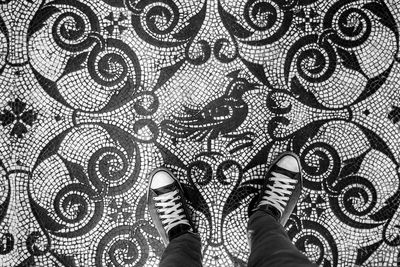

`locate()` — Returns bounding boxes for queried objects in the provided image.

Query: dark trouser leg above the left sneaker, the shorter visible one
[160,233,203,267]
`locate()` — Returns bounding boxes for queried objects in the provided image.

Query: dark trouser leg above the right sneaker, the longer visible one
[247,211,317,267]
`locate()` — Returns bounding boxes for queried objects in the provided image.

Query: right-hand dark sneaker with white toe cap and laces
[252,152,302,226]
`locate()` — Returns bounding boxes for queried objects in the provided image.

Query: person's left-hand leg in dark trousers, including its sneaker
[147,168,202,267]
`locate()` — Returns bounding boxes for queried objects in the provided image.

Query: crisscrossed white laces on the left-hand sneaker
[154,190,190,233]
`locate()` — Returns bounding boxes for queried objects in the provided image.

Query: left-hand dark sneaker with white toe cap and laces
[147,168,195,246]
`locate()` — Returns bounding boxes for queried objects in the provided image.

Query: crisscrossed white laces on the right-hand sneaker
[260,172,297,214]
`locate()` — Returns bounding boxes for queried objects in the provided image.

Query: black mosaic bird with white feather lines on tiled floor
[161,71,258,154]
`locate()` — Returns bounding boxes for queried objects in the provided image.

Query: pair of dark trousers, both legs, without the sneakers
[160,211,317,267]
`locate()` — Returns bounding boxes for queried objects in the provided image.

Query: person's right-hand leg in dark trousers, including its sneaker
[248,152,316,267]
